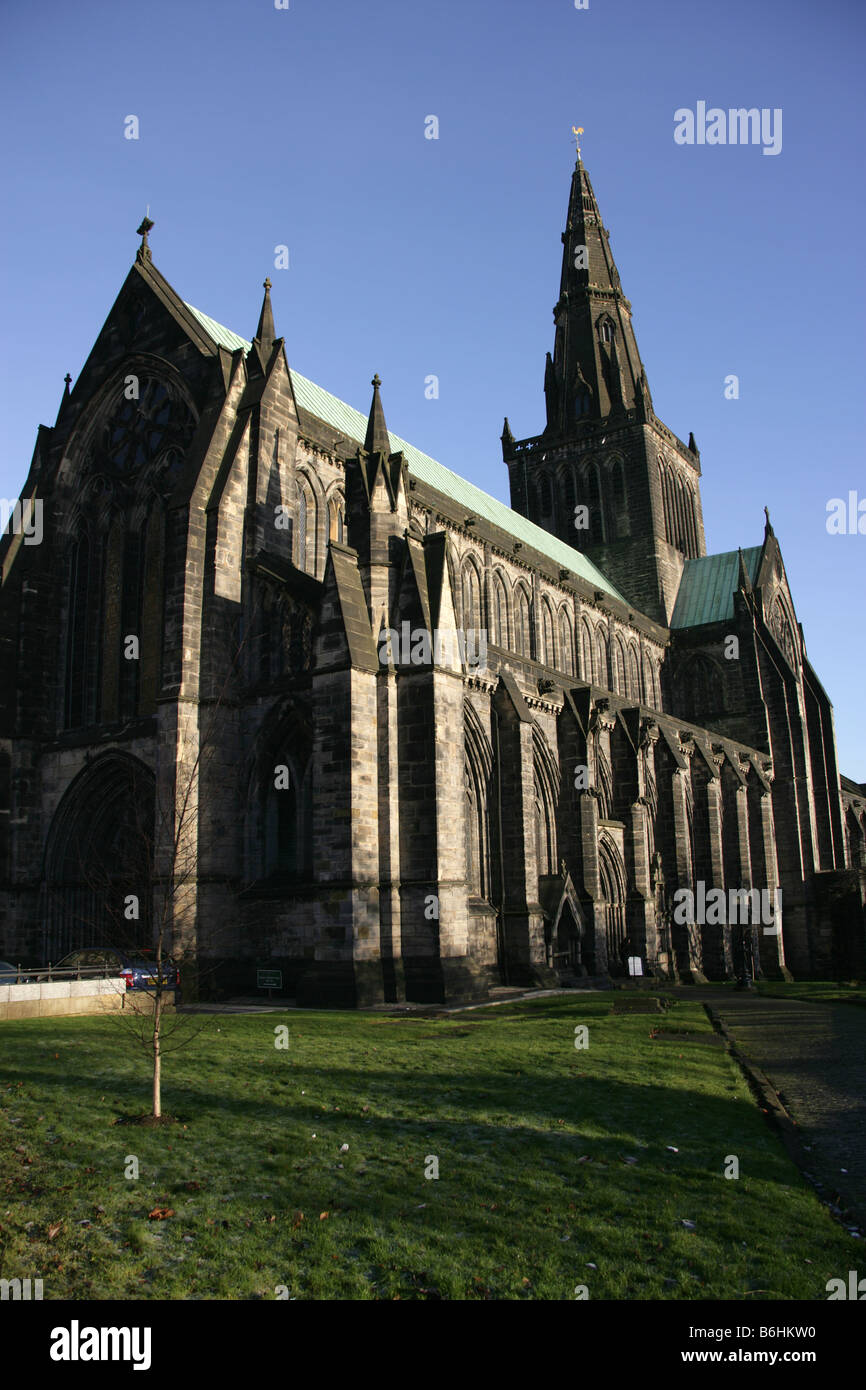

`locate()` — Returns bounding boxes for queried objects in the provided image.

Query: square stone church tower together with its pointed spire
[502,147,706,623]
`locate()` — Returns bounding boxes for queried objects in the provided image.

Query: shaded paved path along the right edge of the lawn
[677,987,866,1234]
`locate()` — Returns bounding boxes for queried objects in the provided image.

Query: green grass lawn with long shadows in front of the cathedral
[0,995,862,1301]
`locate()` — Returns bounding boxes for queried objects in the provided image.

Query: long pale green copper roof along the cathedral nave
[186,304,625,603]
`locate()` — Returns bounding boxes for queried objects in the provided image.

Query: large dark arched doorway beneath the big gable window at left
[43,752,154,960]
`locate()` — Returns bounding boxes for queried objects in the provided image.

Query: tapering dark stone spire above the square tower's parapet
[545,152,649,434]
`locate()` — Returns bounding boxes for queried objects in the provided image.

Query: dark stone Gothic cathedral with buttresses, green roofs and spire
[0,153,866,1006]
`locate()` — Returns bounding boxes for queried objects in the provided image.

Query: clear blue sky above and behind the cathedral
[0,0,866,781]
